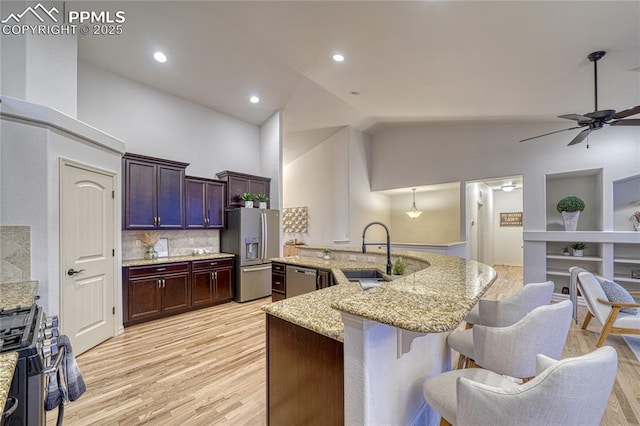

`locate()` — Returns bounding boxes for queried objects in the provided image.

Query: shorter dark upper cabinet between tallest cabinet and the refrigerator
[185,176,227,229]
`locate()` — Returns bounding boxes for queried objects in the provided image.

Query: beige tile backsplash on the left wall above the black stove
[0,226,31,283]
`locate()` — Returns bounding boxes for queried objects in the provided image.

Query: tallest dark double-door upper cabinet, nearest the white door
[122,153,188,229]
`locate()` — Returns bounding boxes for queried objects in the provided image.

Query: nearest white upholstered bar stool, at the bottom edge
[423,346,618,426]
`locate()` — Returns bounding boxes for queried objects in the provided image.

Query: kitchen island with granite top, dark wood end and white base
[263,248,496,425]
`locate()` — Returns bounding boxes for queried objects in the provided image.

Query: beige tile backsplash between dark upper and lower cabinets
[122,229,220,260]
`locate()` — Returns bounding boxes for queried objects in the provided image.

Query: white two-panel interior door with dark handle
[60,160,116,354]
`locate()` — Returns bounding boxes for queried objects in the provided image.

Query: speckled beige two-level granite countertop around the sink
[262,248,497,341]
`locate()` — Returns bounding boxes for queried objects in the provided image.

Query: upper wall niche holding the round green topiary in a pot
[545,169,603,231]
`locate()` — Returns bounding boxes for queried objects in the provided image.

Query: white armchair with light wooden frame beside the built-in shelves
[577,272,640,347]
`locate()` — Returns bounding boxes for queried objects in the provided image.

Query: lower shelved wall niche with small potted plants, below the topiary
[547,241,602,293]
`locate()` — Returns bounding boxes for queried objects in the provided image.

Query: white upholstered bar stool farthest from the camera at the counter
[464,281,554,328]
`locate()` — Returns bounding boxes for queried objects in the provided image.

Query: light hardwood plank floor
[47,266,640,426]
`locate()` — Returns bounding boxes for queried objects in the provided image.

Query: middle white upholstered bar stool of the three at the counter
[447,300,573,380]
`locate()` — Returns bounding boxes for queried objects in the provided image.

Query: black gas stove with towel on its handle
[0,303,58,426]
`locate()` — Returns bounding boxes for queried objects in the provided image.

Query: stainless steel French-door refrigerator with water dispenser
[220,208,280,302]
